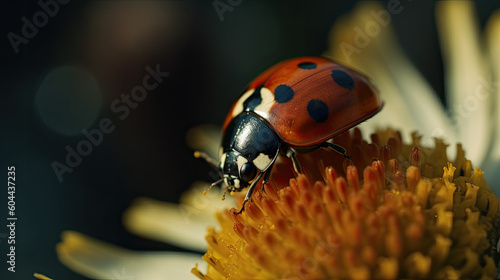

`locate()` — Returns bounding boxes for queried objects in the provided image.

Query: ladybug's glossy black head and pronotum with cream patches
[219,112,279,191]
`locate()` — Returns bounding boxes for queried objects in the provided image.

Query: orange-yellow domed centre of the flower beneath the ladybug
[192,129,500,280]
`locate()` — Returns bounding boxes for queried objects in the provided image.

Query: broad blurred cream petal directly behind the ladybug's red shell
[326,2,455,147]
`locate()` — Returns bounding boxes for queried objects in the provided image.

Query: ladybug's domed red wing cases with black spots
[223,57,383,148]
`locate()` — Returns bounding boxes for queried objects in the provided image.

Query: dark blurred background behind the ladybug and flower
[0,0,499,279]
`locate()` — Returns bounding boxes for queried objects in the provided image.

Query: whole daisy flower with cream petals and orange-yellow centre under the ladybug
[57,1,500,279]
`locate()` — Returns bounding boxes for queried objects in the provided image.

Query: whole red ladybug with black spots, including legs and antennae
[195,57,383,214]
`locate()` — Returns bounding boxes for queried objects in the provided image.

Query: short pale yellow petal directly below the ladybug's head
[124,183,235,251]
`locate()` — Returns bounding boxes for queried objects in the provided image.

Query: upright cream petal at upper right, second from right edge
[436,1,493,164]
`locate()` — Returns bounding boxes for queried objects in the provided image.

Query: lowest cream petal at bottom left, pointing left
[56,231,204,280]
